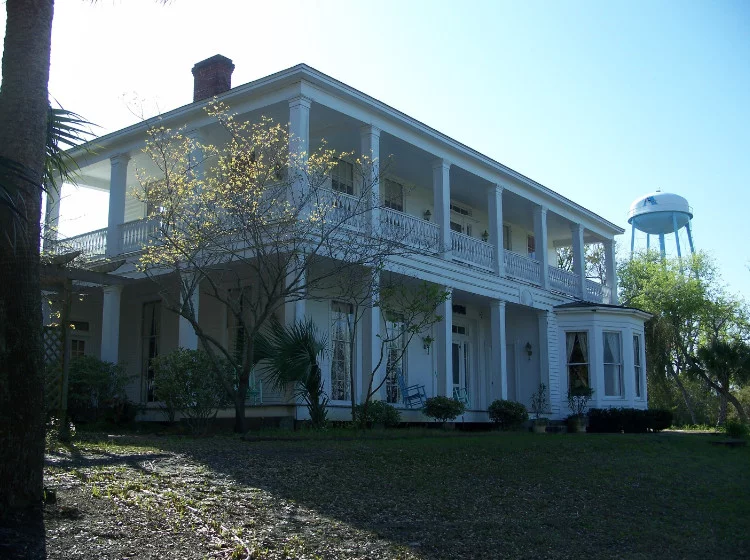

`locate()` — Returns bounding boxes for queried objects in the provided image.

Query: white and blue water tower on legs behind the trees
[628,191,695,257]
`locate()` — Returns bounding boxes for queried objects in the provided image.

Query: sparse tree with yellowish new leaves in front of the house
[139,104,434,431]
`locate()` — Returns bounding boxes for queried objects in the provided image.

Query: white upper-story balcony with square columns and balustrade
[46,66,622,303]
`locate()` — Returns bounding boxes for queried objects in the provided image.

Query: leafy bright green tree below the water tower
[619,252,750,423]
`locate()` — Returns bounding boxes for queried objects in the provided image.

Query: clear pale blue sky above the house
[2,0,750,299]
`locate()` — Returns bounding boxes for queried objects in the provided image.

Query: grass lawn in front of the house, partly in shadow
[45,431,750,559]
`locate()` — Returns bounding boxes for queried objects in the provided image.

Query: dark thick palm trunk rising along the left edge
[0,0,54,558]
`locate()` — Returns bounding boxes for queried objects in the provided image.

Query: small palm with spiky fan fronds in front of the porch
[254,318,328,428]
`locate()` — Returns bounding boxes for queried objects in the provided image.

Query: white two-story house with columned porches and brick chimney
[46,56,647,421]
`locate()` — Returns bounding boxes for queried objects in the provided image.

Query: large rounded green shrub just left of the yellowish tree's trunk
[153,348,227,434]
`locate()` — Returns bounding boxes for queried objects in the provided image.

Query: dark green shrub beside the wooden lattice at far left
[45,356,128,422]
